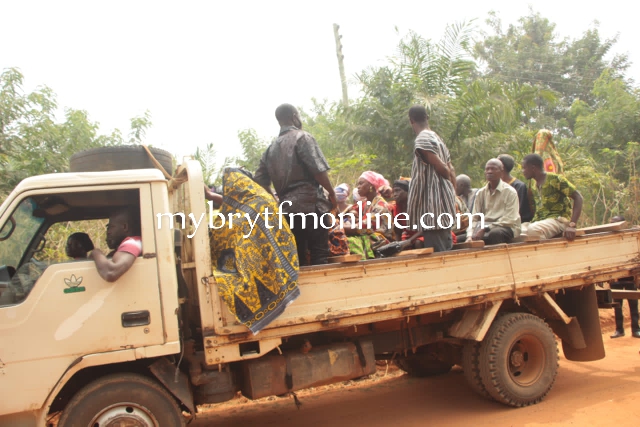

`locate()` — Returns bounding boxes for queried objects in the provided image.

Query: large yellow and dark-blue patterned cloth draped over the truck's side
[211,168,300,334]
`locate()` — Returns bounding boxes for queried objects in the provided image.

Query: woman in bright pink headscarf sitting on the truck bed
[344,171,393,259]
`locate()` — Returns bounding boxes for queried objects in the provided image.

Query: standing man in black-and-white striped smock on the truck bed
[407,105,456,252]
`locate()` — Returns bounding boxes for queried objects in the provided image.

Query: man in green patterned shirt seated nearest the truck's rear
[522,154,582,240]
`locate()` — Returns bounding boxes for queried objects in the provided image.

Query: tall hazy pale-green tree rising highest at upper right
[474,10,628,136]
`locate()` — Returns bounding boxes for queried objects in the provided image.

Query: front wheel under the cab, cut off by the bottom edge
[58,373,186,427]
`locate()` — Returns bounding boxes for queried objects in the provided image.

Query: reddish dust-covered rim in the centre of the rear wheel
[507,335,546,387]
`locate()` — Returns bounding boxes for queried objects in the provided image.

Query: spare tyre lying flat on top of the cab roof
[69,145,173,175]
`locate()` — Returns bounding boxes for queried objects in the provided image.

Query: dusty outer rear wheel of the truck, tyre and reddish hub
[478,313,558,407]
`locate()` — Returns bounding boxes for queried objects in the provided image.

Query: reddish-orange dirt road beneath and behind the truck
[192,328,640,427]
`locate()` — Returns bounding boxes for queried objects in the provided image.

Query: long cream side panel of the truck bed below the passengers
[212,229,640,339]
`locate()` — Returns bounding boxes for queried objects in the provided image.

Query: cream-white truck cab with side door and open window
[0,169,180,425]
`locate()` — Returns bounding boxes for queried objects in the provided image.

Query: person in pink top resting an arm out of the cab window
[89,209,142,282]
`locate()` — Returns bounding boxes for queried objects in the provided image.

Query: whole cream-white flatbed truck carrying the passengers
[0,147,640,427]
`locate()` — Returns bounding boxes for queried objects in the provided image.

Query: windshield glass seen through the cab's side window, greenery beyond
[0,198,44,268]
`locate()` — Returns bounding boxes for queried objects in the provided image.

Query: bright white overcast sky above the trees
[0,0,640,171]
